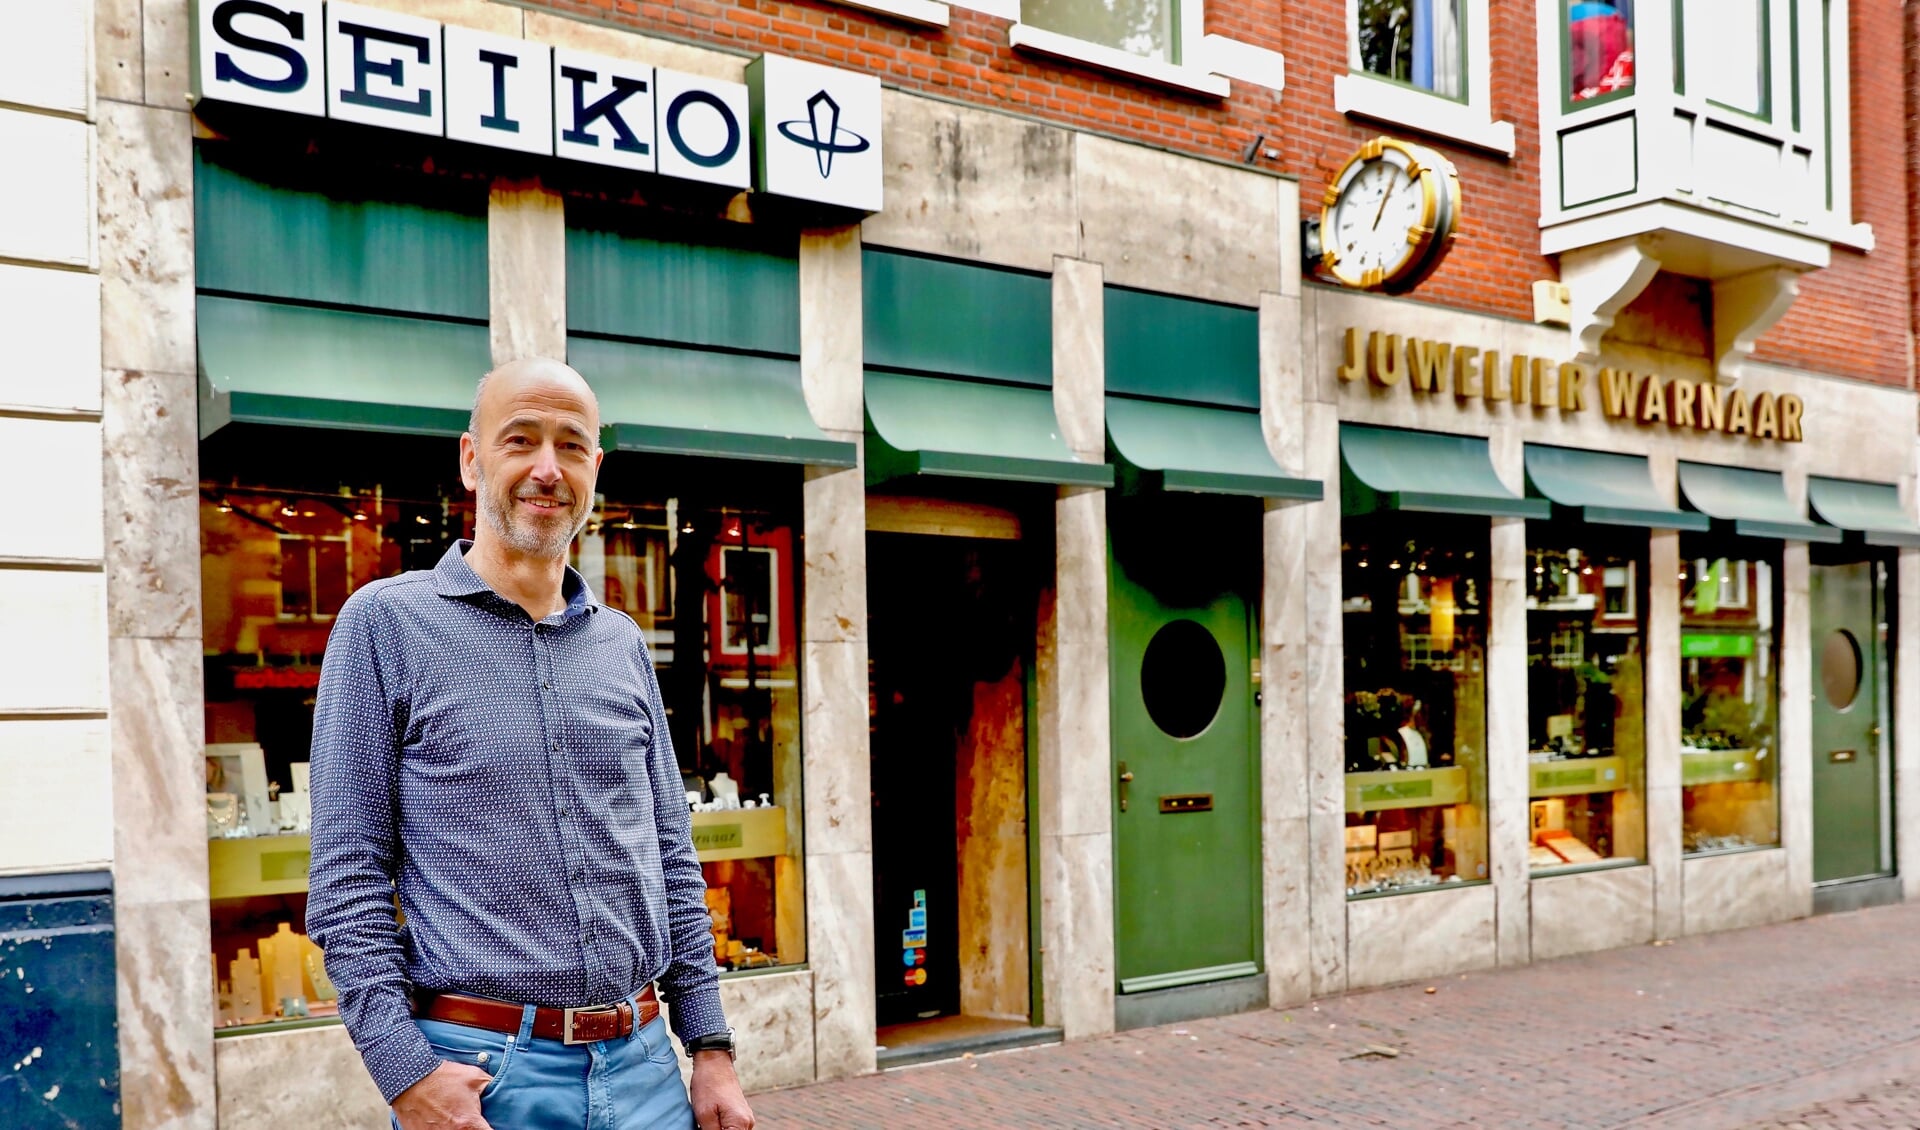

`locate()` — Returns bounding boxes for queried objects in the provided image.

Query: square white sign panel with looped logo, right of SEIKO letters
[747,56,883,211]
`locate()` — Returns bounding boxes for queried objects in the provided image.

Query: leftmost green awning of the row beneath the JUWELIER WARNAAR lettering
[1340,424,1553,518]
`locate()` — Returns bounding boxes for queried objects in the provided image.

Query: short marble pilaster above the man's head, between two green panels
[476,178,566,366]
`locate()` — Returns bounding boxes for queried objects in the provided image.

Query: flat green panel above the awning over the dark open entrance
[860,247,1054,388]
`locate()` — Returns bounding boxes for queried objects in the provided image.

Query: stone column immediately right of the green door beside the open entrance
[1260,287,1313,1009]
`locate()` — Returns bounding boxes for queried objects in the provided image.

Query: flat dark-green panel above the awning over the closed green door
[1104,286,1260,411]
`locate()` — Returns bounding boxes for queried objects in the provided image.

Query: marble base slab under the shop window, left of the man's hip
[213,1020,385,1130]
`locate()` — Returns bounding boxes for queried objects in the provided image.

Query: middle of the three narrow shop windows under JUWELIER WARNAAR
[1526,526,1647,871]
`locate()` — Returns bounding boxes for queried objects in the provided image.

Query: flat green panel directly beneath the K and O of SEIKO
[566,224,801,357]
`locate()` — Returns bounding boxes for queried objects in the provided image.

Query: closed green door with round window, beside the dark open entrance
[1108,501,1260,992]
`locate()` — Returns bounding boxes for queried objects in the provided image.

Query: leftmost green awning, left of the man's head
[198,295,490,437]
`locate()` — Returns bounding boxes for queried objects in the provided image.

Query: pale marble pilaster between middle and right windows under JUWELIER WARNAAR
[1645,529,1686,938]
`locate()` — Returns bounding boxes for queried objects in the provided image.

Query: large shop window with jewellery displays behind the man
[200,428,804,1030]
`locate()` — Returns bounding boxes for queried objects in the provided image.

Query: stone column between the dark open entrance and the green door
[1035,257,1114,1040]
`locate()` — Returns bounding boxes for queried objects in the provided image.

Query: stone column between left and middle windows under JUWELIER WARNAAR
[1486,424,1532,965]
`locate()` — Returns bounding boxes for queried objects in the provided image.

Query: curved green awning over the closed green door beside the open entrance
[1106,397,1327,503]
